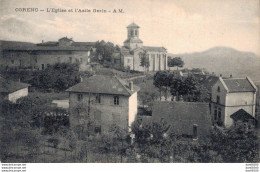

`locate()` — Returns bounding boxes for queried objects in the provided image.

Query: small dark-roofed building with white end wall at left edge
[0,76,30,103]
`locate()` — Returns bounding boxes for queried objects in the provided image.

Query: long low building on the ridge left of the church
[0,37,95,70]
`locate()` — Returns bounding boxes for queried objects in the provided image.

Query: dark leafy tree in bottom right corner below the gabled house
[211,122,259,163]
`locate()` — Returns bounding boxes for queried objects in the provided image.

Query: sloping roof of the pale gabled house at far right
[223,78,256,92]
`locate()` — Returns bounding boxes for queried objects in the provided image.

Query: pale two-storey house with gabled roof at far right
[211,77,257,127]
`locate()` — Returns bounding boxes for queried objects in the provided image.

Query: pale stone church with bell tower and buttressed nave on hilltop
[113,23,168,71]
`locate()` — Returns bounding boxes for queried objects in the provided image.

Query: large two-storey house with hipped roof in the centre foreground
[67,75,139,132]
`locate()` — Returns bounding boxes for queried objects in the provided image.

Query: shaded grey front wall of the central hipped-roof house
[69,93,130,132]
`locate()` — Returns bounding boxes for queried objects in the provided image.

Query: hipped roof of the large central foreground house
[66,75,139,96]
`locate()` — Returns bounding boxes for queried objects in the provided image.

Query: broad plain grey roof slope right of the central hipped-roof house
[151,102,211,136]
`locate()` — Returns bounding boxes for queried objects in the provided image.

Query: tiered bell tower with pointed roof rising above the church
[124,23,143,50]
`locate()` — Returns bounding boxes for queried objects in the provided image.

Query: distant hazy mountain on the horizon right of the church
[168,47,260,81]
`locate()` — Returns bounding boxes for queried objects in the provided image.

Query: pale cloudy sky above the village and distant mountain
[0,0,260,55]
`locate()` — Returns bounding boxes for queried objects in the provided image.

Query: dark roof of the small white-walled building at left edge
[0,76,30,93]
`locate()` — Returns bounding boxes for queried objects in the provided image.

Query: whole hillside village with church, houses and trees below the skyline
[0,23,260,162]
